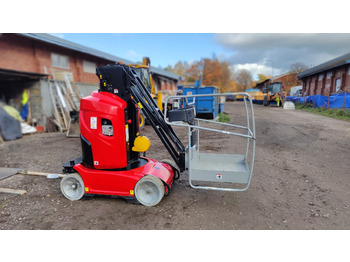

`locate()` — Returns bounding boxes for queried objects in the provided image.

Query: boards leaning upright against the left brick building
[48,70,80,132]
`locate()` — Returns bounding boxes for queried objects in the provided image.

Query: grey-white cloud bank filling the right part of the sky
[215,33,350,75]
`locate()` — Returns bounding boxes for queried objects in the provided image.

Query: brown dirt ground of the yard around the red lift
[0,102,350,230]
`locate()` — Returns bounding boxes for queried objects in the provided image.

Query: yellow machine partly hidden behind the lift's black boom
[128,57,163,129]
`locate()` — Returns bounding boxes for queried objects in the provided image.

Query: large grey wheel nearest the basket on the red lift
[135,175,165,206]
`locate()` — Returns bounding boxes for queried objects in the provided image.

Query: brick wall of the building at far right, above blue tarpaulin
[302,65,350,96]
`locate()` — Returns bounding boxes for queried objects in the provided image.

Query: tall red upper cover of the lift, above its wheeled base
[80,91,127,169]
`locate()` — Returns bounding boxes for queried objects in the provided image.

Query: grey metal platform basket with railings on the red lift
[164,92,255,191]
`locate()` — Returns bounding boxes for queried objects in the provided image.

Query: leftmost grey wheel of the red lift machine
[61,173,85,201]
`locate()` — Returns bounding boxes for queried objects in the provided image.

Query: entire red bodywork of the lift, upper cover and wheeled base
[73,91,174,200]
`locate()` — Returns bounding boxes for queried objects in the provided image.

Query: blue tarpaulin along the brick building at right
[287,93,350,108]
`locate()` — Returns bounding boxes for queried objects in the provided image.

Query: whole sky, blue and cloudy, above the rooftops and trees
[58,33,350,79]
